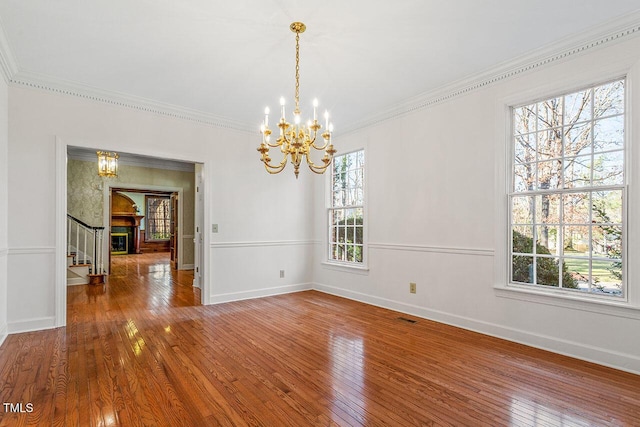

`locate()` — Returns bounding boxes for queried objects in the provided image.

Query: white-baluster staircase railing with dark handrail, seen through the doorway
[67,214,105,274]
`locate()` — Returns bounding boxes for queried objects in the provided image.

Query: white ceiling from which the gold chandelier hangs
[0,0,640,132]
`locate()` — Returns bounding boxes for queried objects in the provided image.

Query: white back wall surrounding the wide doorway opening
[2,86,312,332]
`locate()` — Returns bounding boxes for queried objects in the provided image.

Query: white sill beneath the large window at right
[494,286,640,320]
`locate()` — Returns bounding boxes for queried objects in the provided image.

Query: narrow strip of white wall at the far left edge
[0,71,9,344]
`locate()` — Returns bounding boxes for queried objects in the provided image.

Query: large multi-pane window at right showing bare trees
[509,80,625,297]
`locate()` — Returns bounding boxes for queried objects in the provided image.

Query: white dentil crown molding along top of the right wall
[343,12,640,134]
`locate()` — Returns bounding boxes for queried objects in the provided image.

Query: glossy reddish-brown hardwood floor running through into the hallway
[0,255,640,427]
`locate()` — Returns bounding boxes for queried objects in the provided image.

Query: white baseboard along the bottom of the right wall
[313,283,640,374]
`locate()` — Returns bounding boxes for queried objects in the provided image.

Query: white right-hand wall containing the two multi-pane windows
[314,37,640,373]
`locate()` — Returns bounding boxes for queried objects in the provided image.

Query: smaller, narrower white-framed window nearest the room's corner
[328,150,365,265]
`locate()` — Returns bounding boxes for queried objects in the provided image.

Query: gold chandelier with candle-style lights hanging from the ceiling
[258,22,336,179]
